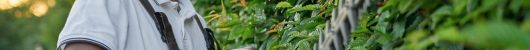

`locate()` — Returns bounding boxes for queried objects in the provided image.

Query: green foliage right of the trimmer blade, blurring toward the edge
[347,0,530,50]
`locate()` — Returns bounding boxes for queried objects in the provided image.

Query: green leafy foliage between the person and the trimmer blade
[195,0,334,50]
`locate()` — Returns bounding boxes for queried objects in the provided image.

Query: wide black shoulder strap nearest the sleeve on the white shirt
[140,0,180,50]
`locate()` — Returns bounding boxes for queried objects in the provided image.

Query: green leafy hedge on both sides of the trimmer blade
[194,0,530,50]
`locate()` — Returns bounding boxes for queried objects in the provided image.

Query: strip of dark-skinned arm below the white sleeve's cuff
[64,43,103,50]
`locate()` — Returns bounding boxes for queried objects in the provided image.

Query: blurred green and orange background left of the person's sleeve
[0,0,74,50]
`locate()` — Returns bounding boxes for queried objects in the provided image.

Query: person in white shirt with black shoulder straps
[57,0,211,50]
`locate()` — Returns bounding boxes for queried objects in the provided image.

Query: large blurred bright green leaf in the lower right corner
[462,21,530,49]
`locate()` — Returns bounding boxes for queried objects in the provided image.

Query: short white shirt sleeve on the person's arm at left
[57,0,120,50]
